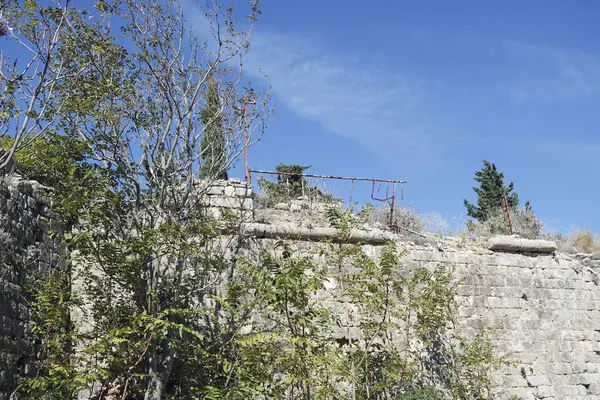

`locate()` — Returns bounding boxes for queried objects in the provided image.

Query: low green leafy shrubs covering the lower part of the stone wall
[17,205,506,400]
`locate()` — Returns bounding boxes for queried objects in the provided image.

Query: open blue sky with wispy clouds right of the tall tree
[227,0,600,232]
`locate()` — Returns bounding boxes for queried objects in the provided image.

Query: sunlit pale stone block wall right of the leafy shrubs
[244,234,600,400]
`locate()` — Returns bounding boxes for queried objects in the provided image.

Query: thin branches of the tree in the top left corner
[0,0,82,169]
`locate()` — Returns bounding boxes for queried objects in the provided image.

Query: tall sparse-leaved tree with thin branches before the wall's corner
[5,0,268,400]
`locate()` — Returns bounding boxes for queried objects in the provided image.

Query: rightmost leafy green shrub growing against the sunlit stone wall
[327,210,506,400]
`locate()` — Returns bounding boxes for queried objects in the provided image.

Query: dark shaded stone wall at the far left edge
[0,175,59,400]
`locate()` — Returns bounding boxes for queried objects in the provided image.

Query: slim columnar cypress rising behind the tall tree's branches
[200,75,227,179]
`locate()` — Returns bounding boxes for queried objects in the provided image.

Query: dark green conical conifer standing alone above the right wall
[464,160,519,222]
